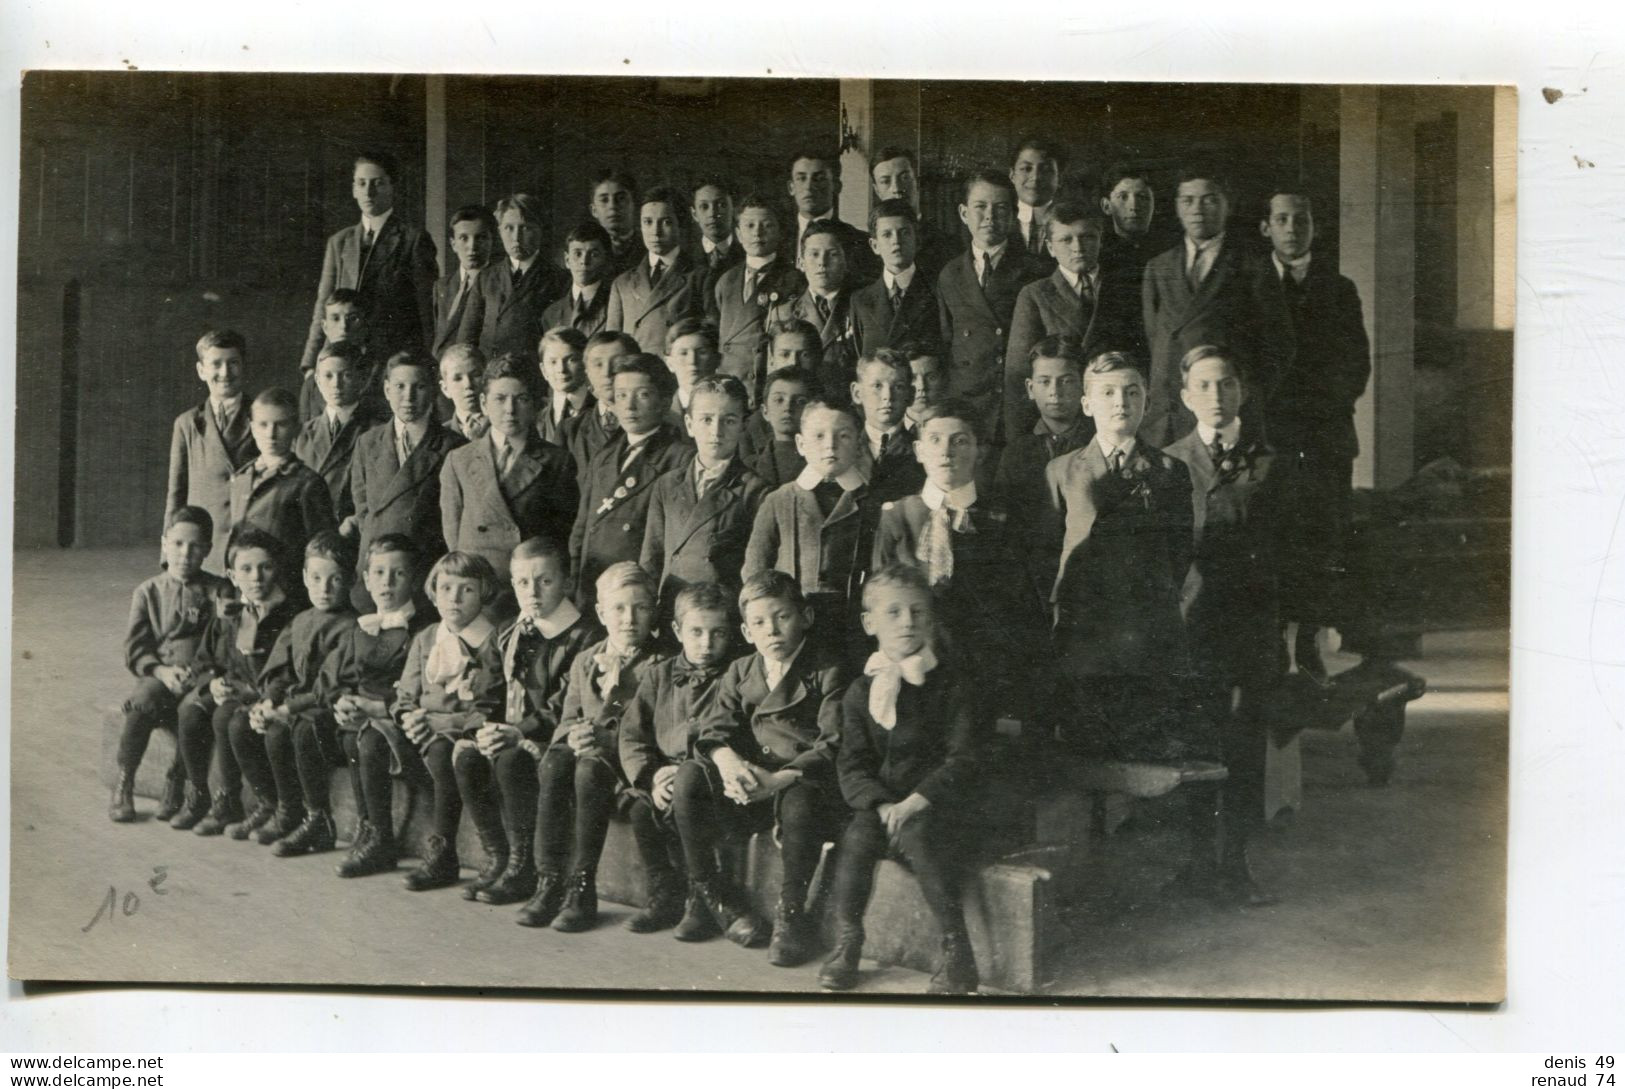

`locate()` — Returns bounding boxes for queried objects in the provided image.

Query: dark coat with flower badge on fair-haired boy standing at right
[1045,440,1194,676]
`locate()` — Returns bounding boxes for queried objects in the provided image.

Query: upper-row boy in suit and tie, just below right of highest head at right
[1004,200,1129,442]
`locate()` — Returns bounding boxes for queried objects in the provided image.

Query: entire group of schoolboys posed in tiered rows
[111,141,1368,993]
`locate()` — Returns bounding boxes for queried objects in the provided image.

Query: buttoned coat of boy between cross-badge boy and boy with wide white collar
[639,457,769,608]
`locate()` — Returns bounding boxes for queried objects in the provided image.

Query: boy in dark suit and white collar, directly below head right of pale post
[852,200,939,354]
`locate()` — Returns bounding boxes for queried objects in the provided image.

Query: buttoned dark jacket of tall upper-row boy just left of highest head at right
[936,248,1038,440]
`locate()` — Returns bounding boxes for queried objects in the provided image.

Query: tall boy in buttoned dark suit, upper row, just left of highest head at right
[936,172,1042,444]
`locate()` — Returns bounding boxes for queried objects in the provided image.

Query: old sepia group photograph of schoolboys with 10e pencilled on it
[8,68,1529,1004]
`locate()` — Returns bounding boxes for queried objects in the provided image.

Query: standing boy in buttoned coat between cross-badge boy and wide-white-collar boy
[639,374,769,614]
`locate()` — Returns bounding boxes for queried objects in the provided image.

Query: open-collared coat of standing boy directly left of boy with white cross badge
[440,432,580,584]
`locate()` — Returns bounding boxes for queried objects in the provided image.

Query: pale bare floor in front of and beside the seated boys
[10,549,1506,1001]
